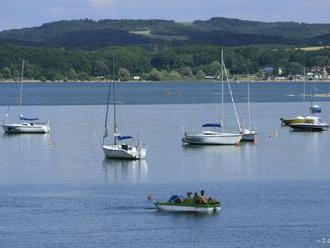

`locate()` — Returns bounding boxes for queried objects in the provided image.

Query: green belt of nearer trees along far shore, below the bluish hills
[0,44,330,81]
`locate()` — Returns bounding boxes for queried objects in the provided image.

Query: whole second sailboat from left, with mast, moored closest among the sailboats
[102,63,147,160]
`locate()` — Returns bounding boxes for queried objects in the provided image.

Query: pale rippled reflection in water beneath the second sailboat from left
[102,159,148,183]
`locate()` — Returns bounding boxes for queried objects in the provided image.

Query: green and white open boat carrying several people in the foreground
[154,191,221,213]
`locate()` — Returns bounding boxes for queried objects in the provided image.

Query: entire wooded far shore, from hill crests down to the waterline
[0,17,330,82]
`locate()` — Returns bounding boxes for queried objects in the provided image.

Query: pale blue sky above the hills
[0,0,330,30]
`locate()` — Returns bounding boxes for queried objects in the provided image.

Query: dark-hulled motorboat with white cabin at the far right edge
[289,116,329,132]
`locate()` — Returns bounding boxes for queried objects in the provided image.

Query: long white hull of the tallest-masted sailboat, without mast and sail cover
[182,132,242,145]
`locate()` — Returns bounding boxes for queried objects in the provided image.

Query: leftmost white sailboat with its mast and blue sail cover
[2,60,50,134]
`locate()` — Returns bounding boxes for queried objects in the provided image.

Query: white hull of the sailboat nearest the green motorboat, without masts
[102,145,147,160]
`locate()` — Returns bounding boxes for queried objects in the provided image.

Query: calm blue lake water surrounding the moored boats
[0,83,330,248]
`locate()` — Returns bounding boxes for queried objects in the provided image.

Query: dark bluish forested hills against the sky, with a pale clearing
[0,17,330,49]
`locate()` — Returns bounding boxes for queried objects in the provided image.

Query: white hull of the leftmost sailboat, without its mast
[2,123,50,134]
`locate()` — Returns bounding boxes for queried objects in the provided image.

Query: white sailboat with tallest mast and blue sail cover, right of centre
[182,51,242,145]
